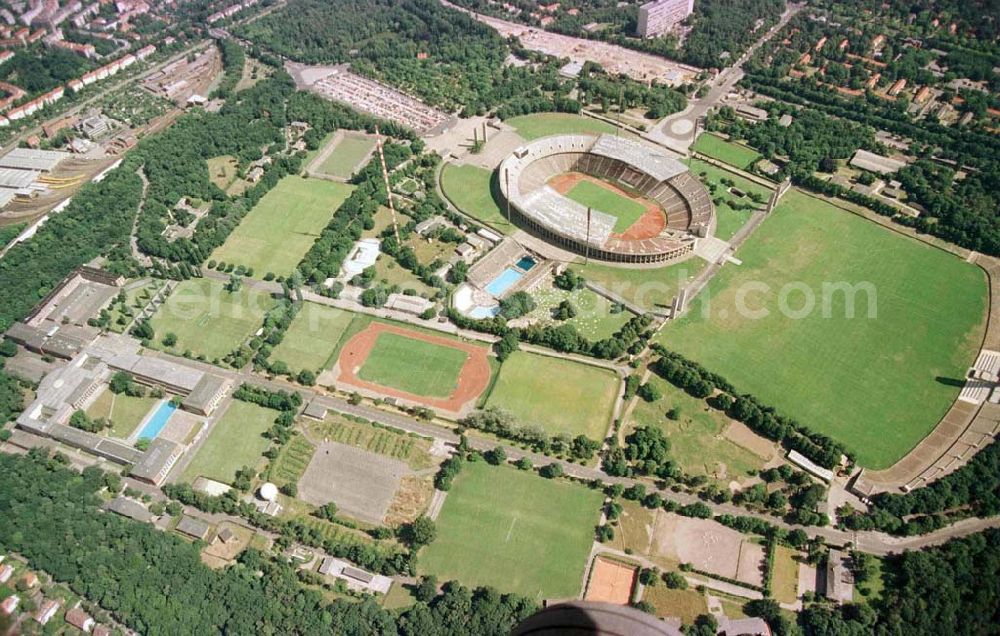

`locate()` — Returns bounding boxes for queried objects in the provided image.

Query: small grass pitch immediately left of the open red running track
[271,302,356,371]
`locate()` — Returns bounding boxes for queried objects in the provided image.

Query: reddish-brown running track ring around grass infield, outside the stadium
[334,322,490,413]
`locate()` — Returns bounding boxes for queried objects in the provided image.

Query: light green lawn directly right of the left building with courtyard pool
[181,400,278,484]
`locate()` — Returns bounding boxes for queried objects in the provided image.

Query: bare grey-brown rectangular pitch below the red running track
[299,442,410,523]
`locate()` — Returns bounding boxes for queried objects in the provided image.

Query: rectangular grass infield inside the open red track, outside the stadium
[358,333,469,397]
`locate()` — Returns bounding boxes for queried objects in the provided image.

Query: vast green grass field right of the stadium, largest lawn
[659,189,987,469]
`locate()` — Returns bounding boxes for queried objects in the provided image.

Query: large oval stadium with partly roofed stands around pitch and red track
[499,134,715,263]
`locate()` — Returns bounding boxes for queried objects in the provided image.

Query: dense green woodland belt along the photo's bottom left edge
[0,453,537,636]
